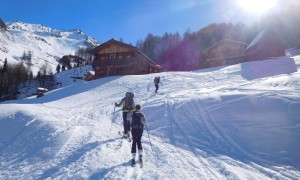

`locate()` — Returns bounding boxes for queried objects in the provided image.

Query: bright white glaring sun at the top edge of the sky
[237,0,277,15]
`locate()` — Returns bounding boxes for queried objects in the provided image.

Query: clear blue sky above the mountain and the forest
[0,0,296,45]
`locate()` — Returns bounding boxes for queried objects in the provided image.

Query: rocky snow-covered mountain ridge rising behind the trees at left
[0,21,99,74]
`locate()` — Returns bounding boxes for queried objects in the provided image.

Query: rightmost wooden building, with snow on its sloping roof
[245,29,285,61]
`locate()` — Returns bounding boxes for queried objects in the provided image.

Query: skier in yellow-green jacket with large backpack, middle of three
[115,92,135,138]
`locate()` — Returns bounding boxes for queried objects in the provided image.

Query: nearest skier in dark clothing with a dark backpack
[130,104,146,167]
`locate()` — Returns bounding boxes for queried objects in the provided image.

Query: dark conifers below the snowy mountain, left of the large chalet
[0,44,93,102]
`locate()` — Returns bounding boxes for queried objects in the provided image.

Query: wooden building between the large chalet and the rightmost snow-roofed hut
[204,39,247,67]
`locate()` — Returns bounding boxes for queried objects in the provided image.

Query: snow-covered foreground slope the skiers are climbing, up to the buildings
[0,56,300,179]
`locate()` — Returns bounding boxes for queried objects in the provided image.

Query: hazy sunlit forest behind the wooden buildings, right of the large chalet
[136,5,300,71]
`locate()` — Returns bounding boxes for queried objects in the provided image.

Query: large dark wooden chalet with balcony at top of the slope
[91,39,160,78]
